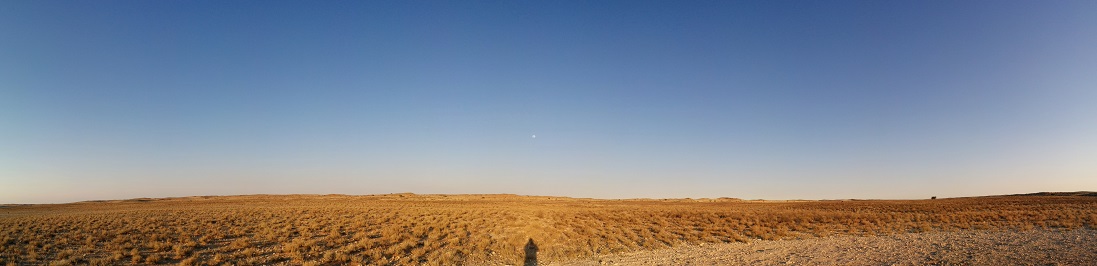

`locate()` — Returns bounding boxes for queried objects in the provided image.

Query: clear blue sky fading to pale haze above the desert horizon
[0,0,1097,203]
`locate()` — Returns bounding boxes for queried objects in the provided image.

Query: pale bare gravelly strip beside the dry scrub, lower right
[542,229,1097,265]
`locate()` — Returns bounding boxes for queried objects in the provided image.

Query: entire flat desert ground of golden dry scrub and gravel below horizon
[0,193,1097,265]
